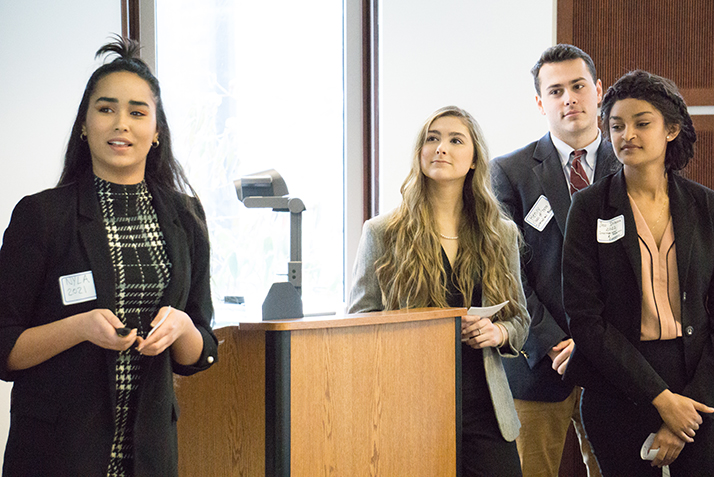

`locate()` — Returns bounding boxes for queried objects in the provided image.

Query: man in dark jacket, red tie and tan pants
[491,45,618,477]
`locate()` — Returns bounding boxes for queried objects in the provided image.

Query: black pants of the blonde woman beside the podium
[461,345,521,477]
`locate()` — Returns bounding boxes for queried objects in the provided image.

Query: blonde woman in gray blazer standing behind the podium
[349,106,530,477]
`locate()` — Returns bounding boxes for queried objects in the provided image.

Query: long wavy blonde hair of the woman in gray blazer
[376,106,526,318]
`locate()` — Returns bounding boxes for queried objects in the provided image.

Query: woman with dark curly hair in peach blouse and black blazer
[563,71,714,476]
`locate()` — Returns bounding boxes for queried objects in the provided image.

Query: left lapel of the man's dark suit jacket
[533,133,570,234]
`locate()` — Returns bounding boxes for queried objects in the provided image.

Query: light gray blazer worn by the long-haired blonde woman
[349,212,530,442]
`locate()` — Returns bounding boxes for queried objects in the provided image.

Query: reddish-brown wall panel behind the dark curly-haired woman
[557,0,714,188]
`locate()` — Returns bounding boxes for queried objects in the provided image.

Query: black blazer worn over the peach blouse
[563,171,714,406]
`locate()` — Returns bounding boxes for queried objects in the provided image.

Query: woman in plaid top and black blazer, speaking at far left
[0,37,217,477]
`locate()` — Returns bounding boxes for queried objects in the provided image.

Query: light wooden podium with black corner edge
[175,308,466,477]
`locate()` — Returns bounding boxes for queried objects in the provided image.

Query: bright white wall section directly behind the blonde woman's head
[379,0,556,213]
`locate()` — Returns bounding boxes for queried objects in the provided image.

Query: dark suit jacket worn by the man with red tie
[491,133,619,402]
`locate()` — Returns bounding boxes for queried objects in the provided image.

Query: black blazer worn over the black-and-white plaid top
[0,174,217,476]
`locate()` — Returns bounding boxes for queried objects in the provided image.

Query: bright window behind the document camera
[156,0,345,324]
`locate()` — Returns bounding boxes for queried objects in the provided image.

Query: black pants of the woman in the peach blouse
[580,338,714,477]
